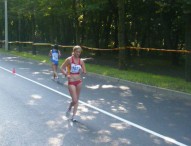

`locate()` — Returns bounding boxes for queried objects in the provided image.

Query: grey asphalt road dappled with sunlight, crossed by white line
[0,54,191,146]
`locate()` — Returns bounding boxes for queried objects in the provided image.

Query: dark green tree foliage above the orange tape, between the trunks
[0,0,187,49]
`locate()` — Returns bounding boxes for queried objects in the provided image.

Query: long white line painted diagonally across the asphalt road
[0,66,188,146]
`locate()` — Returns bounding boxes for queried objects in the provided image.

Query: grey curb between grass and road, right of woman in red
[87,72,191,99]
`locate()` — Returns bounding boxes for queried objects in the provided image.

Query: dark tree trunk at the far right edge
[185,13,191,82]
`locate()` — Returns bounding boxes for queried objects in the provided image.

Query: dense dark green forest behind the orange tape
[0,0,191,81]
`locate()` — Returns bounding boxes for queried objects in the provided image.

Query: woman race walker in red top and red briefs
[60,46,86,121]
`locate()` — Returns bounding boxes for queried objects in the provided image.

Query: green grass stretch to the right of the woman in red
[86,64,191,93]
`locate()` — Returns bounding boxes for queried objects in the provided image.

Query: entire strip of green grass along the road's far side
[0,49,191,93]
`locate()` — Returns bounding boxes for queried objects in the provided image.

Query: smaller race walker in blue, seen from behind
[49,45,61,79]
